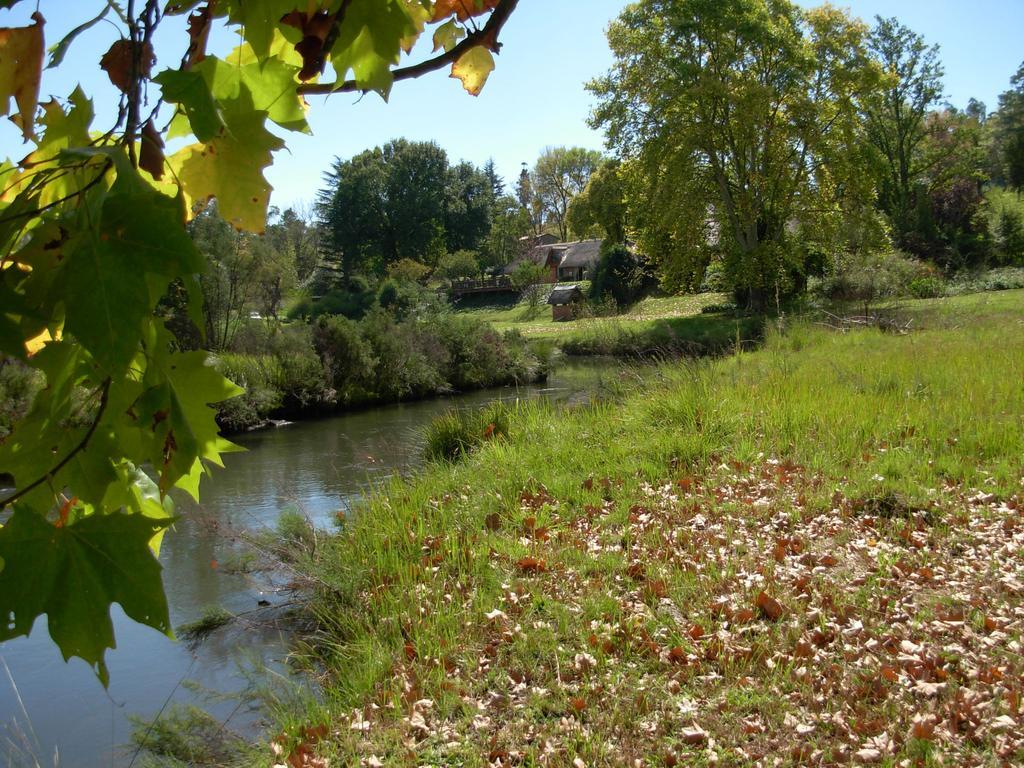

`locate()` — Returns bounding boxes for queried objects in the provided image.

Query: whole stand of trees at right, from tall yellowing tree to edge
[589,0,1024,306]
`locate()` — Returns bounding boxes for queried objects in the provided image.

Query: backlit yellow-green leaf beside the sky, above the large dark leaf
[171,87,285,232]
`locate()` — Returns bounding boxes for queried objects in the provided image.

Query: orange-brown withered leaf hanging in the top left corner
[0,11,46,139]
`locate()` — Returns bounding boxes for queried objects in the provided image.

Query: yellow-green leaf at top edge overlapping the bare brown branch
[331,0,419,99]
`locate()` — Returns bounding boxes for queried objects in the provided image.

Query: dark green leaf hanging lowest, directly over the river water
[0,507,171,686]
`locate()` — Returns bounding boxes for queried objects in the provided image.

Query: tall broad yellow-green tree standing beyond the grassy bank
[589,0,873,305]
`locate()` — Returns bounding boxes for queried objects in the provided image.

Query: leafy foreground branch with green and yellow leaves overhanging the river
[0,0,516,683]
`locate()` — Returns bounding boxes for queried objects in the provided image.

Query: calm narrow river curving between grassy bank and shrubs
[0,361,617,768]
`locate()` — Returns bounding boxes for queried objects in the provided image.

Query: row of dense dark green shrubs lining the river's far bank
[216,309,551,432]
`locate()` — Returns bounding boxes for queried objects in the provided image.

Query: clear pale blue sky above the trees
[0,0,1024,206]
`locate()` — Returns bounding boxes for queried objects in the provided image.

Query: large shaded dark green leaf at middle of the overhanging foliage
[63,158,204,374]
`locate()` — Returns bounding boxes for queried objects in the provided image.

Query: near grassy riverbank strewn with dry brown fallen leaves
[266,291,1024,767]
